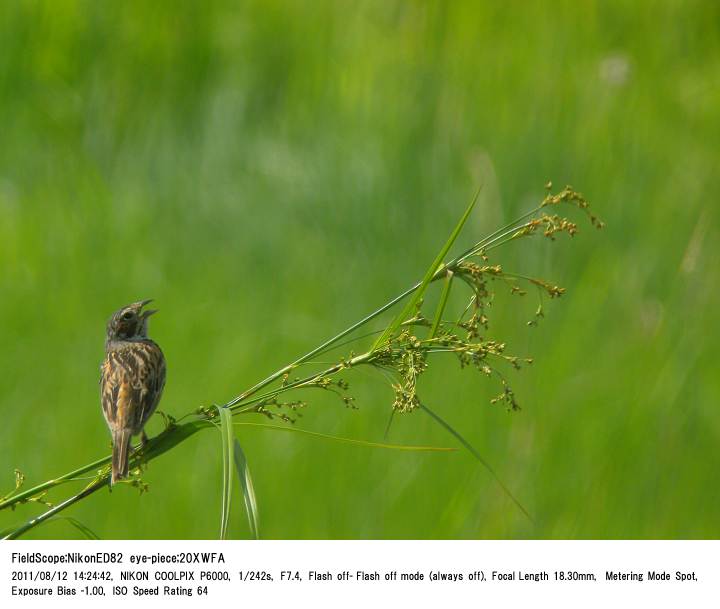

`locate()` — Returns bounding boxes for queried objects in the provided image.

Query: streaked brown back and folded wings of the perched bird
[100,340,165,434]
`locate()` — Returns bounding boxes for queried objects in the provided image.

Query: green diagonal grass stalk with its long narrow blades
[0,187,602,539]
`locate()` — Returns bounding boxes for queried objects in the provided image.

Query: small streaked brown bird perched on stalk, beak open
[100,300,165,484]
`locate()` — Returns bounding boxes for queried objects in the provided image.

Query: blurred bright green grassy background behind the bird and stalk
[0,0,720,538]
